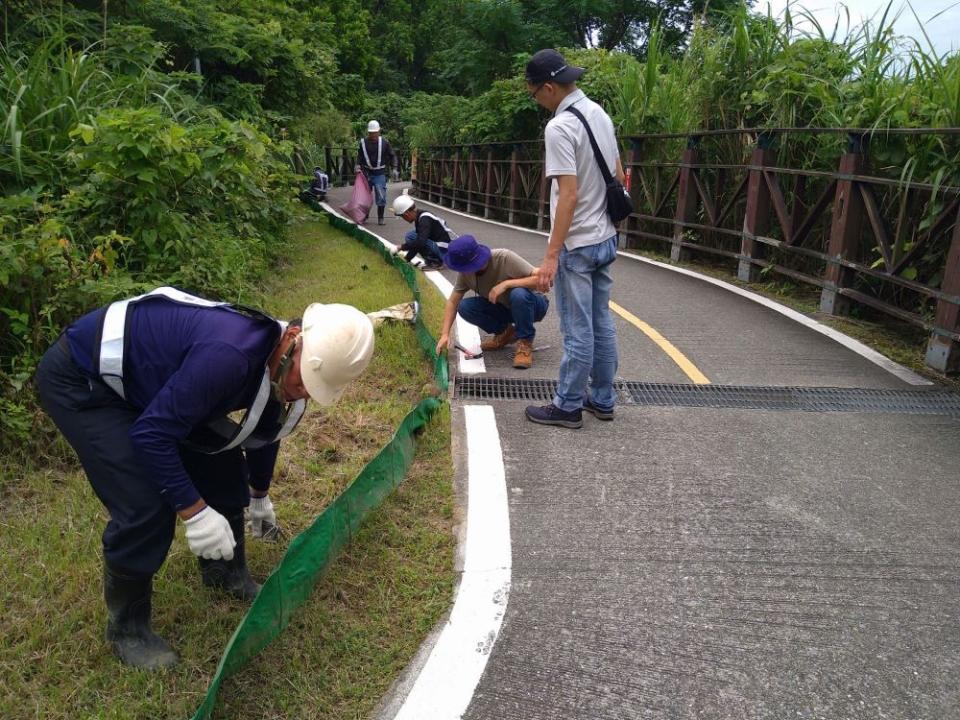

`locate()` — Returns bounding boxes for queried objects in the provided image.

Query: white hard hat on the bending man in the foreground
[300,303,373,405]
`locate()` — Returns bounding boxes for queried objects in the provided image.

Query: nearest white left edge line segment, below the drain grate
[394,405,511,720]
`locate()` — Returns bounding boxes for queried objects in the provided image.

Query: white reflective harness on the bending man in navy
[94,287,307,454]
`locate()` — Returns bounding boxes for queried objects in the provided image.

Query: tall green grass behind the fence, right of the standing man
[612,2,960,184]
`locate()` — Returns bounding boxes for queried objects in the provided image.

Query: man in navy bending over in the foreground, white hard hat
[36,288,374,669]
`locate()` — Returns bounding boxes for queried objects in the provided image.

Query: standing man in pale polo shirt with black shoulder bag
[526,50,624,428]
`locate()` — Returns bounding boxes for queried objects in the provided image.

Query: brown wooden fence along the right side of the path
[413,128,960,372]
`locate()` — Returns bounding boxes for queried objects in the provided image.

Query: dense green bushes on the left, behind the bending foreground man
[0,14,291,448]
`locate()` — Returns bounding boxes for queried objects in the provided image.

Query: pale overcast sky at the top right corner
[754,0,960,55]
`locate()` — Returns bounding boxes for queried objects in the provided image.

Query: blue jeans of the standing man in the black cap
[553,235,618,412]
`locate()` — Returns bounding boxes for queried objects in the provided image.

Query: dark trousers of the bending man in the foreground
[36,337,250,575]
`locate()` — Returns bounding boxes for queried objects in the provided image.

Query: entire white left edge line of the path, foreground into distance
[322,203,511,720]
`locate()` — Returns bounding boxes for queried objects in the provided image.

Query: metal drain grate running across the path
[454,375,960,417]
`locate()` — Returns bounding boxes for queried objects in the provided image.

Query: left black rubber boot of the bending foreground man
[103,563,179,670]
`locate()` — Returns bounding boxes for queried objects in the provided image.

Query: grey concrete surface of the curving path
[324,181,960,720]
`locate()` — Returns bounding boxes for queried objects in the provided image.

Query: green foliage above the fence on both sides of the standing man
[408,7,960,160]
